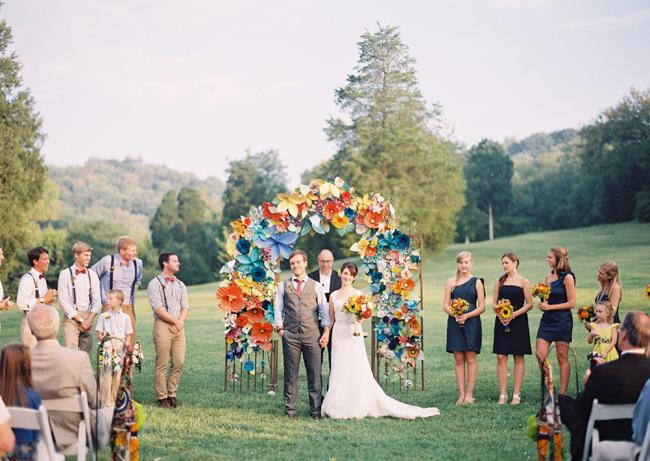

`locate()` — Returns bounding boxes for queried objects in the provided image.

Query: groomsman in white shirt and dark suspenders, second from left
[58,242,102,355]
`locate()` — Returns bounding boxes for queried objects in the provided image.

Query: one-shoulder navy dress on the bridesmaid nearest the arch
[447,277,482,354]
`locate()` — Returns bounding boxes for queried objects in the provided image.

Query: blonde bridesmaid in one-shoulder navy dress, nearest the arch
[442,251,485,405]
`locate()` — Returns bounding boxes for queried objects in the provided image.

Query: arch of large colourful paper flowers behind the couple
[217,178,423,375]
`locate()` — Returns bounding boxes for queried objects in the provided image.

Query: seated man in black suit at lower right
[560,311,650,459]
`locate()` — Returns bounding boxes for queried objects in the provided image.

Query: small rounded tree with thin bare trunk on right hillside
[465,139,513,240]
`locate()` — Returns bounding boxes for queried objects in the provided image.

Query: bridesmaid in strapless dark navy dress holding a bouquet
[492,252,533,405]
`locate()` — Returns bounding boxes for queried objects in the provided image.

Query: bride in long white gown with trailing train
[321,263,440,419]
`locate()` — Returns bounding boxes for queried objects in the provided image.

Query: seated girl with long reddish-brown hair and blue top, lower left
[0,344,41,460]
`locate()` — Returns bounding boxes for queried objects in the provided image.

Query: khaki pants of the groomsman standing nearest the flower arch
[153,319,185,400]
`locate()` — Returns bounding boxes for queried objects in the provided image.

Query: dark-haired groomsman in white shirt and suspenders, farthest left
[16,247,56,347]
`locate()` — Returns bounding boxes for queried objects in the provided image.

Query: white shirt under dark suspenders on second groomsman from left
[58,264,102,319]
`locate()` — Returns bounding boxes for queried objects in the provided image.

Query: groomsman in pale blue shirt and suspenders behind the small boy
[91,235,142,341]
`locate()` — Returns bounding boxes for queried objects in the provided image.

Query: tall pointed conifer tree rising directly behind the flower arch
[303,26,464,250]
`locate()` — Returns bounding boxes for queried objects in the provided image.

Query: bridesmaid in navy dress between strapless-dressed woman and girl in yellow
[535,247,576,394]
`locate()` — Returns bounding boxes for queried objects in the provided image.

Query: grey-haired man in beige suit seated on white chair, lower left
[27,304,97,453]
